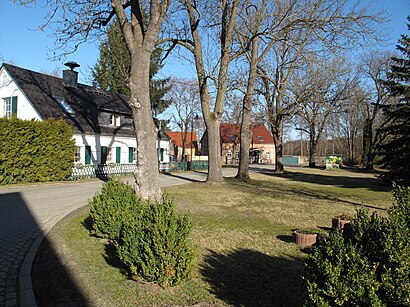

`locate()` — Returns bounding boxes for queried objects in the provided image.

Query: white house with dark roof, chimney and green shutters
[0,62,170,165]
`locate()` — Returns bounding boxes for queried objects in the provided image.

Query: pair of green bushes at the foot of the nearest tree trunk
[90,180,194,287]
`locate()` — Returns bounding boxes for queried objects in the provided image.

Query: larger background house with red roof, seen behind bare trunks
[201,123,275,164]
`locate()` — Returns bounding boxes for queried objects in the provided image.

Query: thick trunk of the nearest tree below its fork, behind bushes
[130,52,161,199]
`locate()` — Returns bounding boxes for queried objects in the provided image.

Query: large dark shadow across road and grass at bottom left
[0,192,88,306]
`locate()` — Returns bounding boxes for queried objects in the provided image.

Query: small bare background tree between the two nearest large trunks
[167,78,200,161]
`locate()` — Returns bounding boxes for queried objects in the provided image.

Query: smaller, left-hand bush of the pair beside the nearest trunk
[89,179,142,240]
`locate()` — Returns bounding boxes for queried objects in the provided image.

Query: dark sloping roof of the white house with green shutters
[3,64,135,136]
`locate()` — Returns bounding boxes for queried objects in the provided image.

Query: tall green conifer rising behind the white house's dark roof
[92,21,170,115]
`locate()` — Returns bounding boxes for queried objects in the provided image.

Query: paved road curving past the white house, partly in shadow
[0,168,247,306]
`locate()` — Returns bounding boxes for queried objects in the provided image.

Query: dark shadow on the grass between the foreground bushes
[200,249,303,306]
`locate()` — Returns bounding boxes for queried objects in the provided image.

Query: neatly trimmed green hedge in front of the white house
[0,118,75,184]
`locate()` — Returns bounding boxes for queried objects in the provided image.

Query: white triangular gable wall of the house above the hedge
[0,67,41,120]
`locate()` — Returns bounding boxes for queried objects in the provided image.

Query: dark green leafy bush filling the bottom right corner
[305,187,410,306]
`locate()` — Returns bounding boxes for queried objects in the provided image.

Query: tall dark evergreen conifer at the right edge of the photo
[380,16,410,185]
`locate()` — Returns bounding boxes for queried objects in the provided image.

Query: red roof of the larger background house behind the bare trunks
[220,123,274,144]
